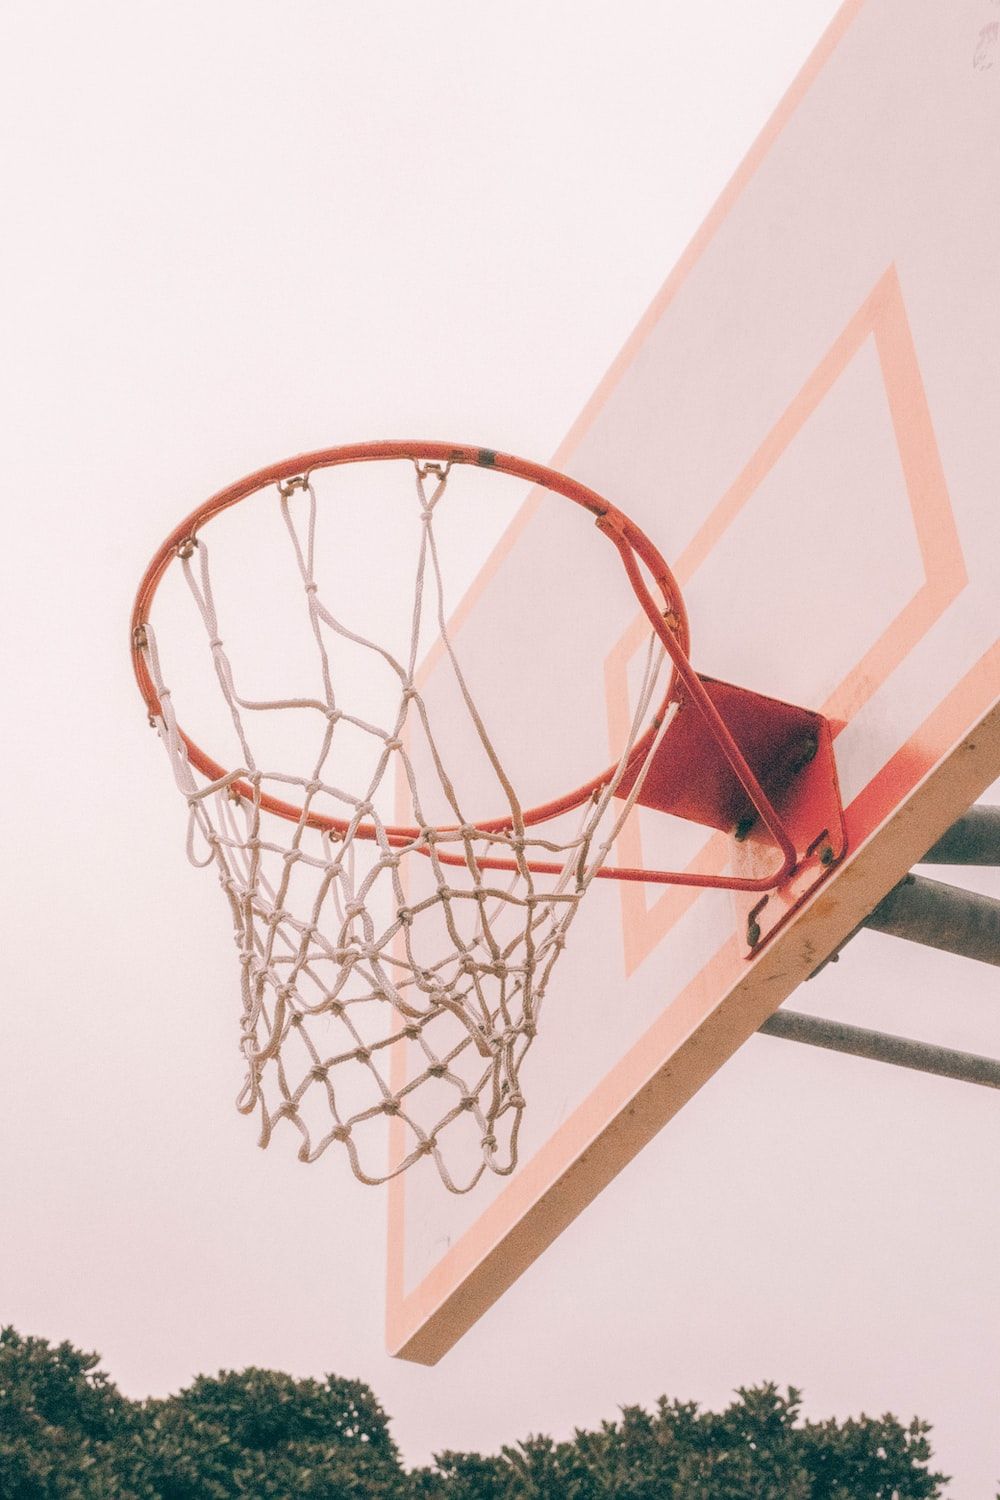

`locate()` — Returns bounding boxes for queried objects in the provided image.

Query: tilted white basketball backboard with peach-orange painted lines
[387,0,1000,1364]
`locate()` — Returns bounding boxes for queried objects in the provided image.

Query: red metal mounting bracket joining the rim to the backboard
[618,674,847,957]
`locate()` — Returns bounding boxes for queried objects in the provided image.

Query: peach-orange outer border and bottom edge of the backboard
[387,0,1000,1364]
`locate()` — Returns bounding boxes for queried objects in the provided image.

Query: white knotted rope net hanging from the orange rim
[142,465,672,1193]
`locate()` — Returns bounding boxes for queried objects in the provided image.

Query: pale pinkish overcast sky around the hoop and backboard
[0,0,1000,1500]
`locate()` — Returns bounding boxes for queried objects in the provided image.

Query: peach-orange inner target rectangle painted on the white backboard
[604,266,969,975]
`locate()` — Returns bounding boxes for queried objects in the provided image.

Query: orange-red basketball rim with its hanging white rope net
[132,443,839,1191]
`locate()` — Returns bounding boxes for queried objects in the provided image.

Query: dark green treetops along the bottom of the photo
[0,1329,946,1500]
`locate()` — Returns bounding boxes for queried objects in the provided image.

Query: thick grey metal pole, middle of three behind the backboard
[862,875,1000,965]
